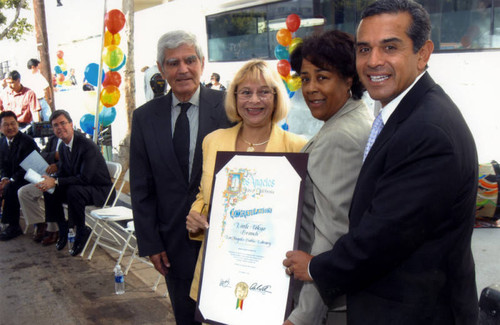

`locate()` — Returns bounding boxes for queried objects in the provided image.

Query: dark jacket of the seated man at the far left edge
[0,132,40,184]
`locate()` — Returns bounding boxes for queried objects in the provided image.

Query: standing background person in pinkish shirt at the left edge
[0,70,41,128]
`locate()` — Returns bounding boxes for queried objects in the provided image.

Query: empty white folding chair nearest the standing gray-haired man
[87,170,135,264]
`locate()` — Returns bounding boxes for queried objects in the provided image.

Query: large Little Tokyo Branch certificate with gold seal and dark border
[197,152,308,325]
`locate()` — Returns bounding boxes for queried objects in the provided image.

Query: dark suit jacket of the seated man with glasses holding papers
[56,132,112,206]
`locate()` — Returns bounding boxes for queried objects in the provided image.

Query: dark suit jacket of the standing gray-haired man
[130,86,230,279]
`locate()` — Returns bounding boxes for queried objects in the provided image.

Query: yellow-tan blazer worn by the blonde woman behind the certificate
[190,123,307,300]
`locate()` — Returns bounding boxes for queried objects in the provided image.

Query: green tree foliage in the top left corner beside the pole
[0,0,33,42]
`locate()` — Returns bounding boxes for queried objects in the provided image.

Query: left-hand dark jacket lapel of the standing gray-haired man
[149,90,185,183]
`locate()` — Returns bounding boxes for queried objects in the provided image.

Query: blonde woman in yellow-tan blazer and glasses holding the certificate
[186,60,307,306]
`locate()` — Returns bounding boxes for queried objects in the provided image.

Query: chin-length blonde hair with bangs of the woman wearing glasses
[225,59,290,123]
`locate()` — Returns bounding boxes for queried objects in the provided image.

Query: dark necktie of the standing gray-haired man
[173,103,191,181]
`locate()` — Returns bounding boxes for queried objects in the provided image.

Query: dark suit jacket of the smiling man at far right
[309,73,477,325]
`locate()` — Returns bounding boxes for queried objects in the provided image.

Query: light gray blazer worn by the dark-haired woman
[289,99,373,325]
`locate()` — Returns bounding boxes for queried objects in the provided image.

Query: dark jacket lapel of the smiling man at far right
[361,72,435,166]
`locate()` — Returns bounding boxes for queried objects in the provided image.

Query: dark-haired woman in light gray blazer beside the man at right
[285,30,373,325]
